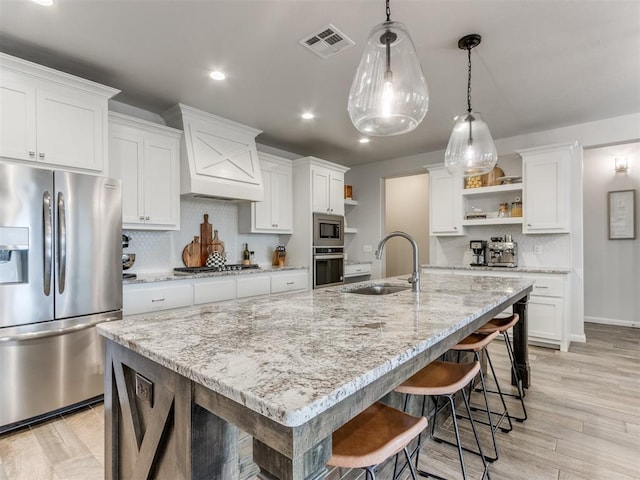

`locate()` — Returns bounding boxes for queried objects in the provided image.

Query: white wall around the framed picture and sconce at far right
[583,143,640,327]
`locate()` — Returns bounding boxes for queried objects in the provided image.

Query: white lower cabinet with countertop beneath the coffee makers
[423,268,571,352]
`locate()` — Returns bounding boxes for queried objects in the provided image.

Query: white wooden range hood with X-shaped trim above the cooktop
[162,104,264,202]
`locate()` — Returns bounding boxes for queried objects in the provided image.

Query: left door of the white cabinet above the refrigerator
[0,76,36,160]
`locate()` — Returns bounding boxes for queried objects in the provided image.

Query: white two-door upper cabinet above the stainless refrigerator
[0,54,118,173]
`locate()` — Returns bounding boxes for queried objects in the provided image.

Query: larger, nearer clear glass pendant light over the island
[347,0,429,136]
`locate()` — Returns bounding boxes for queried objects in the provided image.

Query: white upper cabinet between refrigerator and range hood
[109,112,182,230]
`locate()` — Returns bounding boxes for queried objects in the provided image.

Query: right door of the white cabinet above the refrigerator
[36,89,106,171]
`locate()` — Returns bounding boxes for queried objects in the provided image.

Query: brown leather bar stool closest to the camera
[327,402,428,480]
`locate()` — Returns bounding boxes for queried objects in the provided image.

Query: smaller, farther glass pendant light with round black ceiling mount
[444,33,498,177]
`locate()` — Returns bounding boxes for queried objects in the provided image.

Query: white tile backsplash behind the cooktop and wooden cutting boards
[123,197,280,273]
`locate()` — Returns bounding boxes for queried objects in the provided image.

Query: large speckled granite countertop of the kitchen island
[98,274,533,426]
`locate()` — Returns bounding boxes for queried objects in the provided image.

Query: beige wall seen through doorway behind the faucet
[384,173,429,277]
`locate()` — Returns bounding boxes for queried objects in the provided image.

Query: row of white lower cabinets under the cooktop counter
[122,270,309,315]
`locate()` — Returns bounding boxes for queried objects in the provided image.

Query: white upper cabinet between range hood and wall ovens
[238,152,293,234]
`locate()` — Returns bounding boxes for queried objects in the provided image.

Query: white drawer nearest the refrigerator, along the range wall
[122,282,193,315]
